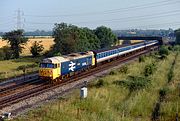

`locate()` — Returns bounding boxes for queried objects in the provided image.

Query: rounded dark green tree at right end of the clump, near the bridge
[95,26,117,48]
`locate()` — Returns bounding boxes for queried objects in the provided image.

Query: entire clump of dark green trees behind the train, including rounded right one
[52,23,117,54]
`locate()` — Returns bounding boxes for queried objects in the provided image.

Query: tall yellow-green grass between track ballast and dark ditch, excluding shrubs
[15,50,180,121]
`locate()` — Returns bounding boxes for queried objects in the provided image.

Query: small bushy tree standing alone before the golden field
[30,41,44,57]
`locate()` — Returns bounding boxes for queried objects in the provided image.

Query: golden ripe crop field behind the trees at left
[0,38,54,55]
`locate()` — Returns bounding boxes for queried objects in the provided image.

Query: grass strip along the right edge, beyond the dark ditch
[160,54,180,121]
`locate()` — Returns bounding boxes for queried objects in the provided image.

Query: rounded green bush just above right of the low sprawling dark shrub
[144,63,156,77]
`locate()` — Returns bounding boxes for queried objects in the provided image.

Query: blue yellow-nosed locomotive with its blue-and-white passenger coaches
[39,40,159,83]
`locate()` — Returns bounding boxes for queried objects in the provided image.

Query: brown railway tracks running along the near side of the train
[0,47,155,109]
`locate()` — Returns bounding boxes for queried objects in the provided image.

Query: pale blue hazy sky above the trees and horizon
[0,0,180,32]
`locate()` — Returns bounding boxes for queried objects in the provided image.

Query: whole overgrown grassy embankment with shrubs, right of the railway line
[15,45,180,121]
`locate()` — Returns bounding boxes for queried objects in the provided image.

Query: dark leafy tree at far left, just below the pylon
[3,30,28,58]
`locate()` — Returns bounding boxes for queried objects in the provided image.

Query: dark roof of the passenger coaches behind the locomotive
[93,42,144,53]
